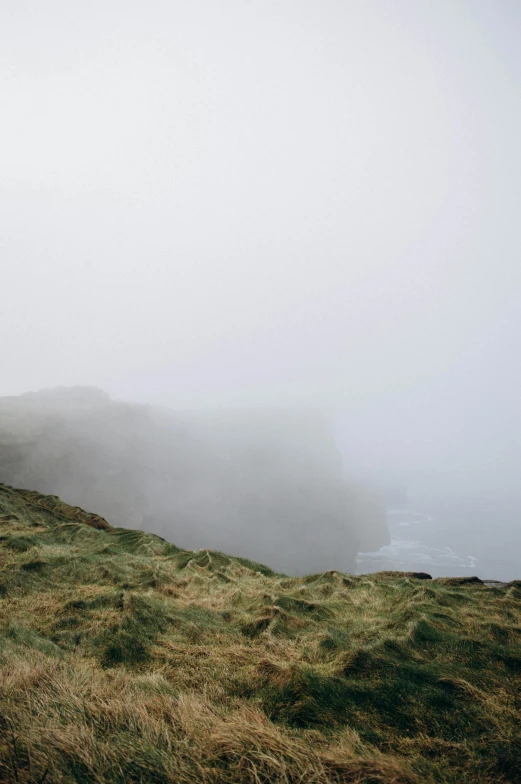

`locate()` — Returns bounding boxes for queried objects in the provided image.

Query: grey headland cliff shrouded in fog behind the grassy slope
[0,388,388,573]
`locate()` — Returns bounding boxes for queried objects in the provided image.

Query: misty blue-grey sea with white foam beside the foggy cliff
[357,505,521,581]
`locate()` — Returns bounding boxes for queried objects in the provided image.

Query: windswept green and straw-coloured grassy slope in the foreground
[0,485,521,784]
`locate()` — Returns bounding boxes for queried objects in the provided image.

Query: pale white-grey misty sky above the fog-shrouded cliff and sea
[0,0,521,496]
